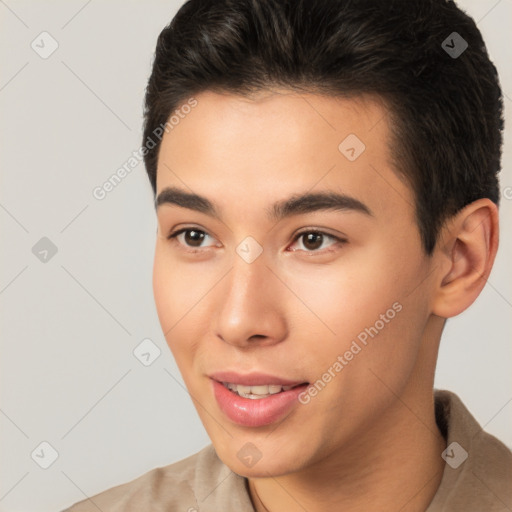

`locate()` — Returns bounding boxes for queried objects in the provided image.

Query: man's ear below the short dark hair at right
[432,199,499,318]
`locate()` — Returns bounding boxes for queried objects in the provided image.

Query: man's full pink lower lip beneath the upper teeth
[212,379,308,427]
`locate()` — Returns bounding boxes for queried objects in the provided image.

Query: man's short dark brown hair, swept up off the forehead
[144,0,503,254]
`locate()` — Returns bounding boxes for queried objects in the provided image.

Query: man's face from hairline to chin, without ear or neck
[153,91,440,476]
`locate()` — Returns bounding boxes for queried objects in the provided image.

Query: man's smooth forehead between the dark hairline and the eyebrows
[157,90,412,220]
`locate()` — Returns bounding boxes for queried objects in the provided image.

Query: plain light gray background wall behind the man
[0,0,512,512]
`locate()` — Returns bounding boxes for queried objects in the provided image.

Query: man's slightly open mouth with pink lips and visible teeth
[210,372,308,427]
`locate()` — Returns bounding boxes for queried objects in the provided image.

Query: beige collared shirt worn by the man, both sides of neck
[62,390,512,512]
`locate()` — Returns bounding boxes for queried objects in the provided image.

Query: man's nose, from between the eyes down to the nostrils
[214,255,287,348]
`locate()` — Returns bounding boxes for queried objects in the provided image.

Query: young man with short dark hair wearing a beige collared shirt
[63,0,512,512]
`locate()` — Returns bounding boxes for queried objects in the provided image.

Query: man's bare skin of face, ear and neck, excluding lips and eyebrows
[153,90,498,512]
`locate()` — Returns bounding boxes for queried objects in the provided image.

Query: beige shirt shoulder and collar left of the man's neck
[62,444,252,512]
